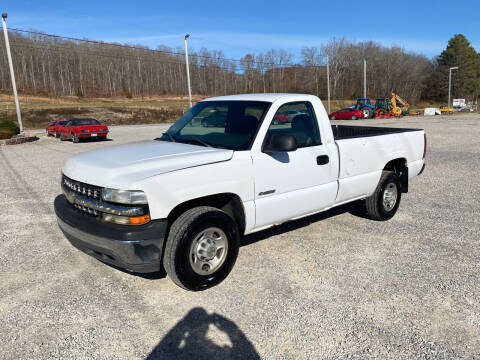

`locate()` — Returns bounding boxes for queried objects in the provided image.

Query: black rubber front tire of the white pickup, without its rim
[163,206,240,291]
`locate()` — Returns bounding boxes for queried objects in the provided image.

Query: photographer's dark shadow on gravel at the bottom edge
[146,307,261,360]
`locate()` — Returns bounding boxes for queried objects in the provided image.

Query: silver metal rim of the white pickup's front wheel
[189,227,228,275]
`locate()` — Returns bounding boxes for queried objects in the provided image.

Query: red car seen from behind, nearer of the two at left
[60,119,108,143]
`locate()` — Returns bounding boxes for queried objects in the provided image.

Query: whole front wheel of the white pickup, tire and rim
[163,206,240,291]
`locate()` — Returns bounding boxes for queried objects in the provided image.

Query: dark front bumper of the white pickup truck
[54,195,167,273]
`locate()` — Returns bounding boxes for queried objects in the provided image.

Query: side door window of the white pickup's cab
[265,102,322,148]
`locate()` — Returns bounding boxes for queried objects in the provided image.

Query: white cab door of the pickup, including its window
[252,101,338,227]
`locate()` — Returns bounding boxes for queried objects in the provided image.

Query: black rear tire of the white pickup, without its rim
[365,170,402,221]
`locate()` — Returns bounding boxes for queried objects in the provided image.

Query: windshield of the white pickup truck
[159,101,271,150]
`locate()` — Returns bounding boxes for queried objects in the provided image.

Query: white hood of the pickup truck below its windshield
[63,140,233,190]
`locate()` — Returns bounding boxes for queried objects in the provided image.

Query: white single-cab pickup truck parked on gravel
[54,94,426,291]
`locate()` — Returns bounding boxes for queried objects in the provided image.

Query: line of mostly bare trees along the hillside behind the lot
[0,31,480,101]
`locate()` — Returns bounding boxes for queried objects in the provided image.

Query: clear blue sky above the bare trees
[0,0,480,58]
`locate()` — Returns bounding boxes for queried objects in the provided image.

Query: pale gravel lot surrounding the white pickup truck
[0,114,480,359]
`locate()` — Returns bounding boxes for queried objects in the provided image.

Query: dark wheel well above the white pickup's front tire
[168,193,245,234]
